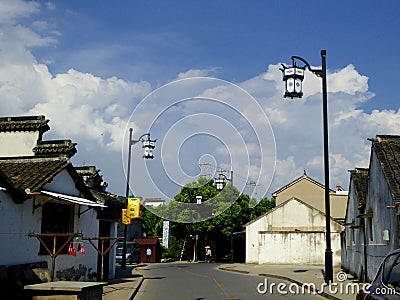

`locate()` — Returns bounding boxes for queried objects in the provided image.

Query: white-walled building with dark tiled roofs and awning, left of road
[0,116,120,286]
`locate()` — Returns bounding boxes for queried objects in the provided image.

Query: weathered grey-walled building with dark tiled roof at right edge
[342,135,400,280]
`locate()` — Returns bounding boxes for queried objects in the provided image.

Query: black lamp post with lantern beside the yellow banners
[121,128,156,269]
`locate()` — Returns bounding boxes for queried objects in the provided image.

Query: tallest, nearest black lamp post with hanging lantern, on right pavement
[281,50,333,283]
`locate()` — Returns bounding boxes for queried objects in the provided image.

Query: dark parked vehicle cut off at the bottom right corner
[356,249,400,300]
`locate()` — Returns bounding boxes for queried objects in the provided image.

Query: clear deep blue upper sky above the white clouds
[33,0,400,113]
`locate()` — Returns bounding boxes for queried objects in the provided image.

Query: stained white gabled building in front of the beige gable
[246,198,344,266]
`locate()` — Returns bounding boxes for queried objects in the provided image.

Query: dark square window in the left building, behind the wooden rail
[39,202,74,254]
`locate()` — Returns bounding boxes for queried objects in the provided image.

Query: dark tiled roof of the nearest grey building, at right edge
[369,135,400,204]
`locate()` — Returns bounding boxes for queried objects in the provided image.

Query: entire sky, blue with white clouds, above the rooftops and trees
[0,0,400,204]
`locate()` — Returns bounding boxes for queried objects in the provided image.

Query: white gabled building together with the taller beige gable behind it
[246,171,347,265]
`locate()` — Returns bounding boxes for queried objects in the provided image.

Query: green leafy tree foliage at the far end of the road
[141,177,275,258]
